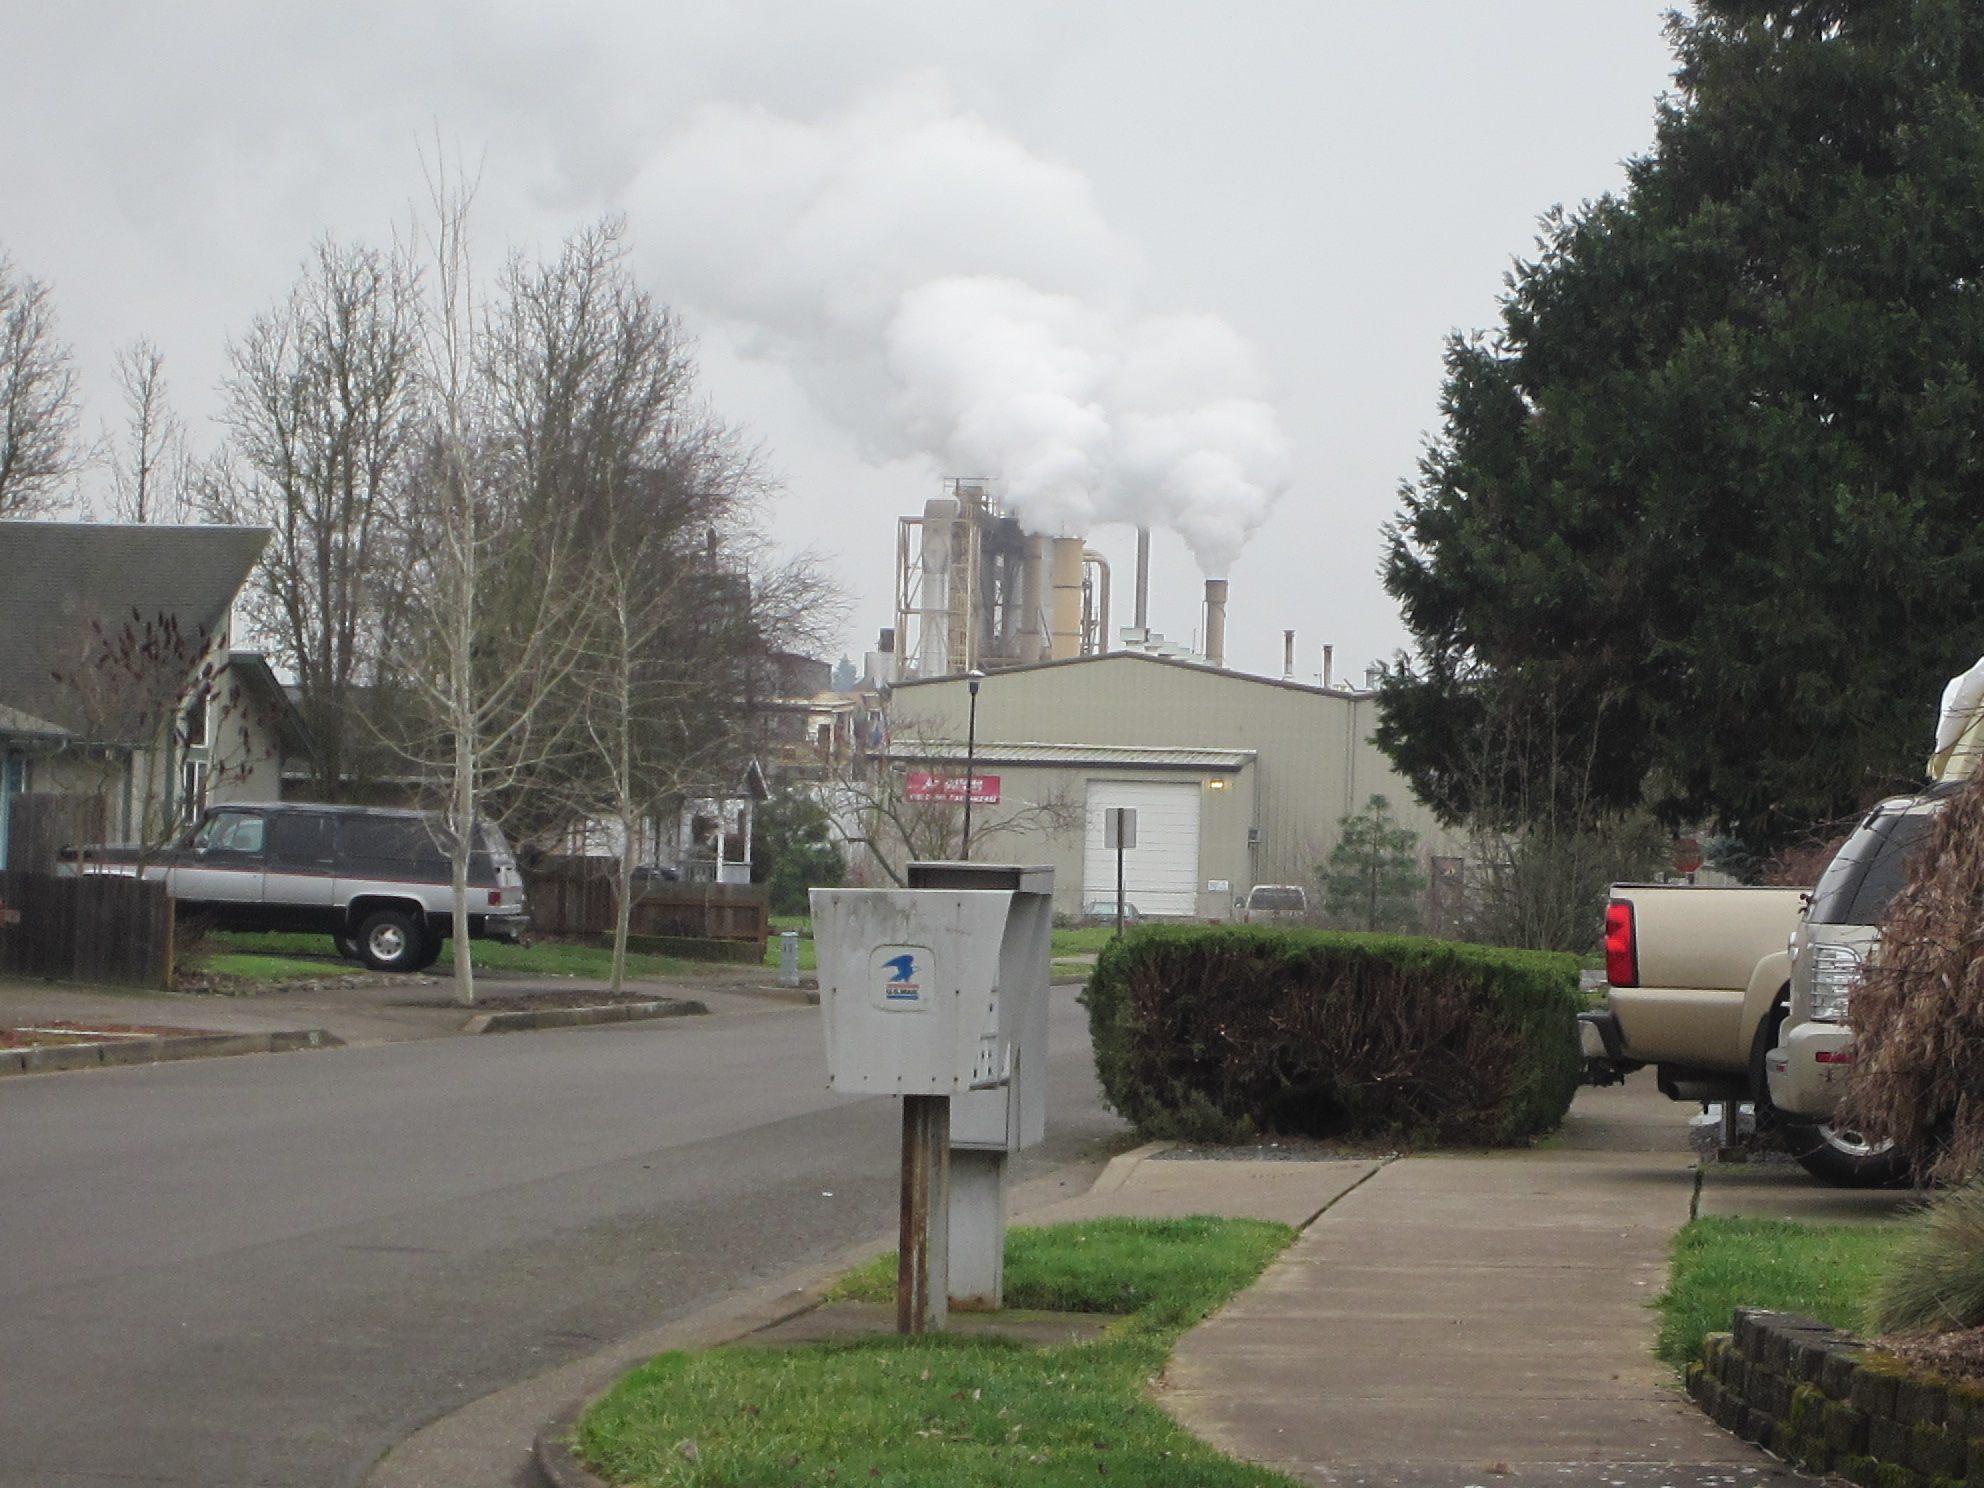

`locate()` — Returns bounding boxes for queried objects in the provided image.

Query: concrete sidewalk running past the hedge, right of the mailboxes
[1161,1081,1813,1488]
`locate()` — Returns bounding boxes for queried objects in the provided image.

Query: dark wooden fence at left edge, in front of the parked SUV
[0,869,173,988]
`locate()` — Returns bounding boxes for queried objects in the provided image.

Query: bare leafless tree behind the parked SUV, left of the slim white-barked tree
[206,240,425,800]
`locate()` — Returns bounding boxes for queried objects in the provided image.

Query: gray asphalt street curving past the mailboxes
[0,988,1125,1488]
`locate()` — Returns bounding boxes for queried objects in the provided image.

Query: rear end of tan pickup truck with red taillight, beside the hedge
[1579,883,1807,1113]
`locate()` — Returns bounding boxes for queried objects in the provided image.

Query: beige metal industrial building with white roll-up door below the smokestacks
[889,651,1458,919]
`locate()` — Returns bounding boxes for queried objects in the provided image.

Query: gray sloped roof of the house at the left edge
[0,520,270,742]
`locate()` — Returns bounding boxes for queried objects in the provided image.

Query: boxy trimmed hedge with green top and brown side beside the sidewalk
[1081,927,1583,1145]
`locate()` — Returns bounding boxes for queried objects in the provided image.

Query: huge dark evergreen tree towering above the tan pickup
[1379,0,1984,849]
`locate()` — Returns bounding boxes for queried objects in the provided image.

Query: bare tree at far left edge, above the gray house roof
[0,250,75,518]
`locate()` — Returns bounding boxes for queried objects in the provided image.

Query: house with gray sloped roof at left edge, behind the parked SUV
[0,520,310,867]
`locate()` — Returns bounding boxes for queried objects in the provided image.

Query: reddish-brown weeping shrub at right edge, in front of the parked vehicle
[1833,774,1984,1182]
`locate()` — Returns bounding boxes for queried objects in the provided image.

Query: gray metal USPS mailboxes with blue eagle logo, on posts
[811,863,1054,1331]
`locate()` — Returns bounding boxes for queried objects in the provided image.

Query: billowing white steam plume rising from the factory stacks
[631,75,1288,575]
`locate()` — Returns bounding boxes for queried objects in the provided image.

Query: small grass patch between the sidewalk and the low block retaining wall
[1659,1218,1903,1369]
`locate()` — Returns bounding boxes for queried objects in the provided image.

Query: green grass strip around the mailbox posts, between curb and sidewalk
[577,1218,1294,1488]
